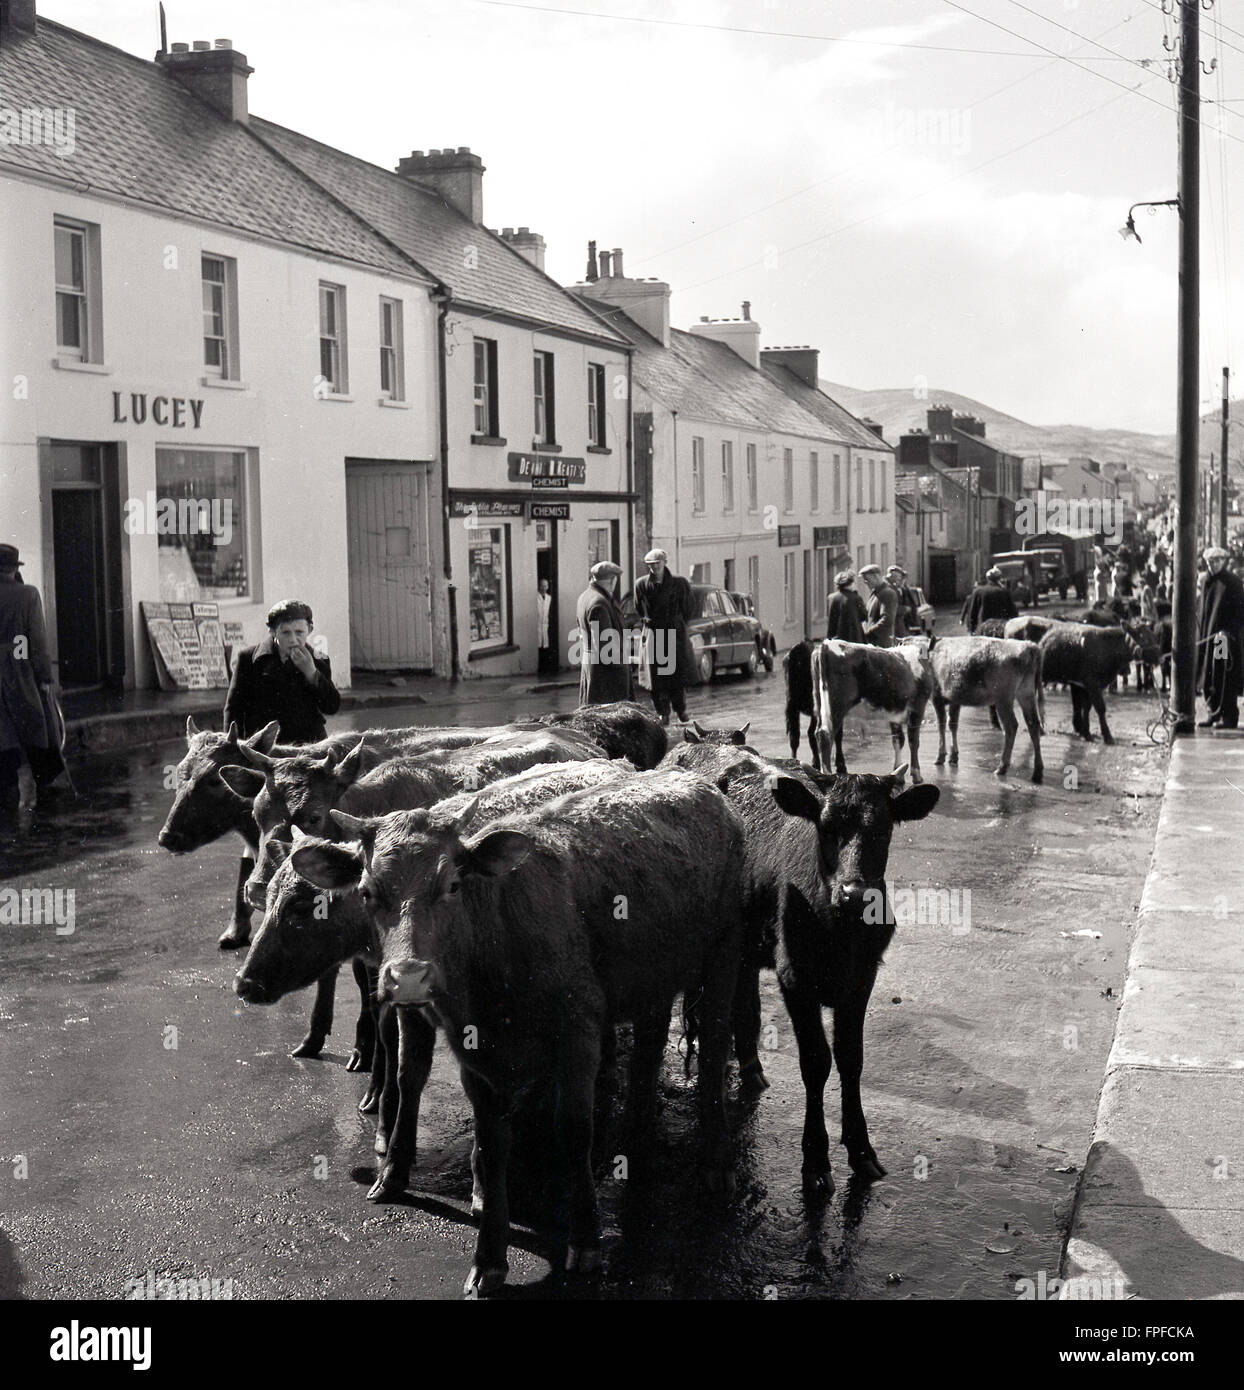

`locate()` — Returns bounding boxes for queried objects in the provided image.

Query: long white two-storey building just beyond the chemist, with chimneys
[574,250,894,648]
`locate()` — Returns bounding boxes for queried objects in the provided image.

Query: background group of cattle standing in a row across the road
[783,609,1169,783]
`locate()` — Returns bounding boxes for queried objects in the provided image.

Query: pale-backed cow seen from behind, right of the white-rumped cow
[928,637,1045,783]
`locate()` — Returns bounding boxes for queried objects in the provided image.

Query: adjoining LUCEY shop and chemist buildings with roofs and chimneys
[0,0,632,687]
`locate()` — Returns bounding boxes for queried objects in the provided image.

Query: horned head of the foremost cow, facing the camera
[290,798,532,1004]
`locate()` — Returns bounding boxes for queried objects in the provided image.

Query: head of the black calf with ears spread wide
[769,767,941,920]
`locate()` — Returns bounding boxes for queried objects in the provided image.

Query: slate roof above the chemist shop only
[250,117,625,343]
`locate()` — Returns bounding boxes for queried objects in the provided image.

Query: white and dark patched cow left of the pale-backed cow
[812,637,934,783]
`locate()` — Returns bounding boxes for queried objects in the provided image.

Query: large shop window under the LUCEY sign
[153,449,252,603]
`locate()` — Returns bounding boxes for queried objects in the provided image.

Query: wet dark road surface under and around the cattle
[0,653,1166,1300]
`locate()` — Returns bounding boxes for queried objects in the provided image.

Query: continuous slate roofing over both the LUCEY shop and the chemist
[0,17,625,346]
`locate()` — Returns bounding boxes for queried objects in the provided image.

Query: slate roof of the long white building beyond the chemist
[577,293,856,443]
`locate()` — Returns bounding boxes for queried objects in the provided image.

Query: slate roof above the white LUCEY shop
[0,17,424,278]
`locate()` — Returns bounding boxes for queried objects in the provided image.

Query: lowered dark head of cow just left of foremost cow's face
[234,831,373,1004]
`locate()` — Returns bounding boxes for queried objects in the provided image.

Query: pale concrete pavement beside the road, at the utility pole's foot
[1062,733,1244,1300]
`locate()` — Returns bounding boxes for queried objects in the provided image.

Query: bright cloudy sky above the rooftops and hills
[39,0,1244,432]
